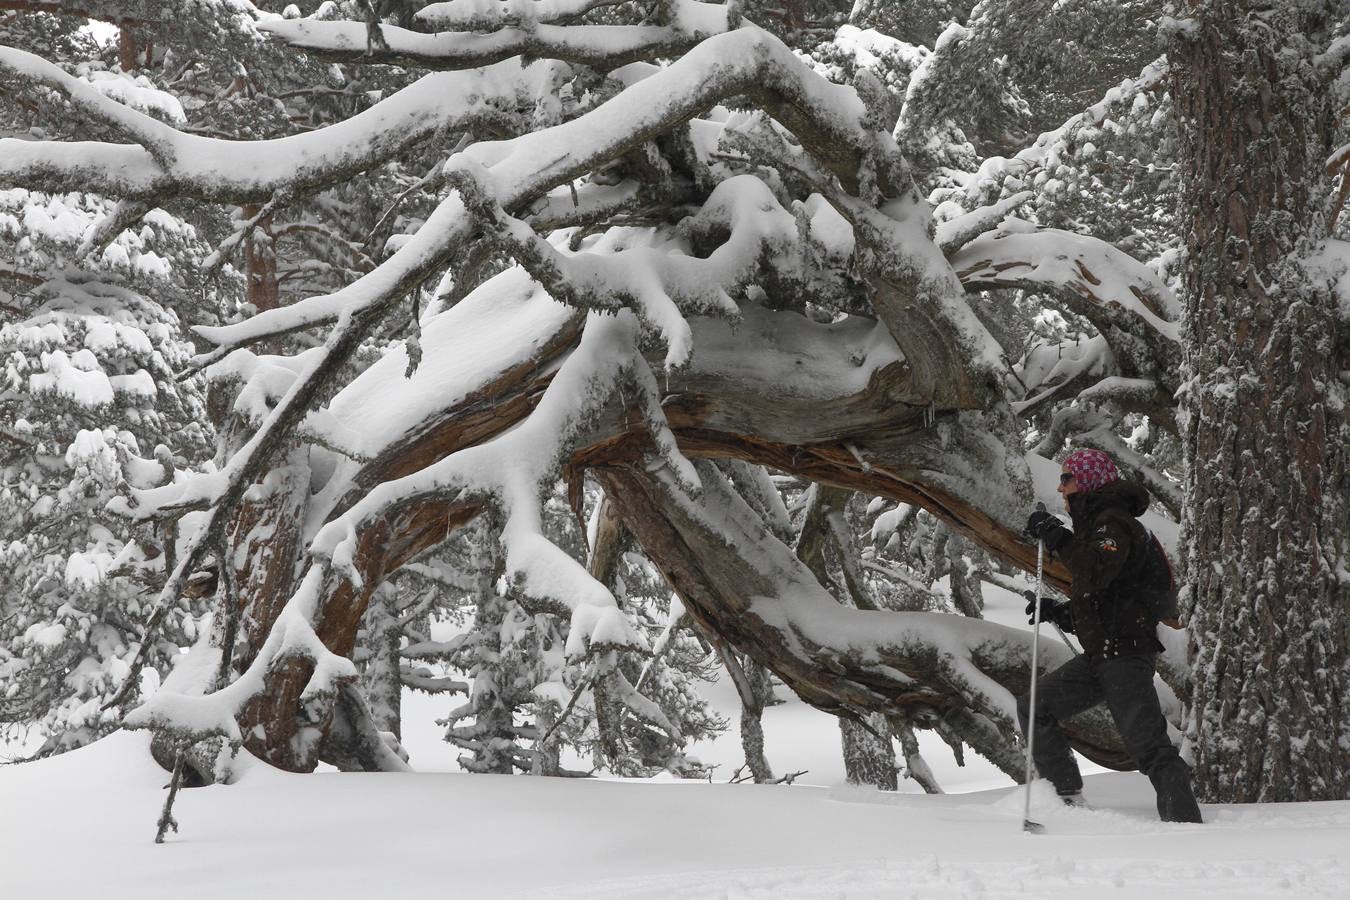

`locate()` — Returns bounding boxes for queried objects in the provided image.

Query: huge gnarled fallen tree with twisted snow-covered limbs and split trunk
[0,0,1225,777]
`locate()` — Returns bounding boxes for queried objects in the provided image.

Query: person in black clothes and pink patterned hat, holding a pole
[1017,449,1202,822]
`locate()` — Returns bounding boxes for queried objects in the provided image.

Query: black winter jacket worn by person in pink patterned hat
[1045,480,1162,658]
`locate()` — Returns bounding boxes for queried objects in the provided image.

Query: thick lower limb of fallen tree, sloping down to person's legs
[597,463,1144,765]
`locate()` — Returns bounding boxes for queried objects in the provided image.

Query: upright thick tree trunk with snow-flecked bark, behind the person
[1173,0,1350,801]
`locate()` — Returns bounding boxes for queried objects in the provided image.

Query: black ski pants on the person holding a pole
[1017,653,1200,822]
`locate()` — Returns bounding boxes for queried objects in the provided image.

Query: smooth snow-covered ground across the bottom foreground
[0,733,1350,900]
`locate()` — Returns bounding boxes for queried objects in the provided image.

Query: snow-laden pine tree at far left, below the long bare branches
[0,272,212,753]
